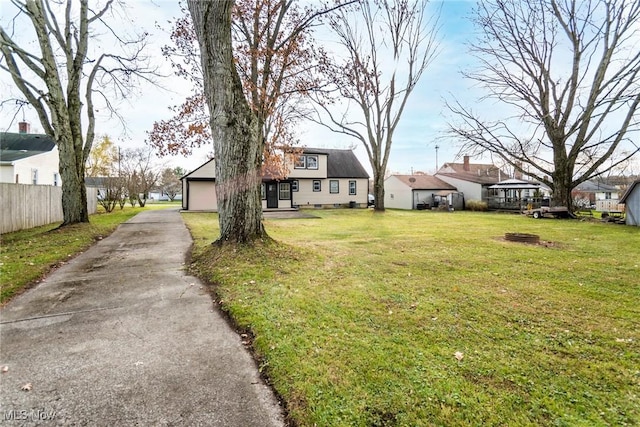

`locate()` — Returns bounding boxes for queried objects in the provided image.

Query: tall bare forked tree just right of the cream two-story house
[316,0,438,211]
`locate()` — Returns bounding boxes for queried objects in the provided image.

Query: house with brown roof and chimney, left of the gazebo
[435,156,508,202]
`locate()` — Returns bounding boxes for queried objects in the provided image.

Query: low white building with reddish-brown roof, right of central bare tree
[384,175,462,209]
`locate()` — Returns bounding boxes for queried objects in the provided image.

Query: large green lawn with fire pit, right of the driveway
[183,210,640,426]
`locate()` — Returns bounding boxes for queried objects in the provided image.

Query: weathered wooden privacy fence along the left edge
[0,183,98,234]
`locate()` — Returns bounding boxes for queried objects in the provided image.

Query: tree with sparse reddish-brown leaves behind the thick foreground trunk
[149,0,327,176]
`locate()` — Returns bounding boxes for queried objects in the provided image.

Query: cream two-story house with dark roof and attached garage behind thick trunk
[182,148,369,211]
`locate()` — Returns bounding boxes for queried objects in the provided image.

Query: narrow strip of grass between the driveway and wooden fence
[0,205,165,304]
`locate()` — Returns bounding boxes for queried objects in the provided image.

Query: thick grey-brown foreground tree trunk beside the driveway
[189,0,266,243]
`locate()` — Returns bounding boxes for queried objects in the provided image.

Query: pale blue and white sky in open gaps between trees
[0,0,474,173]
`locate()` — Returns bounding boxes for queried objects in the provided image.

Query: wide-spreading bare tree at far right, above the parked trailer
[449,0,640,211]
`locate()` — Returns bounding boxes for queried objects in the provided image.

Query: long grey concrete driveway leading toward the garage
[0,210,283,427]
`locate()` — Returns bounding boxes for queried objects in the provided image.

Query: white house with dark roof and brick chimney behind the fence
[0,122,61,186]
